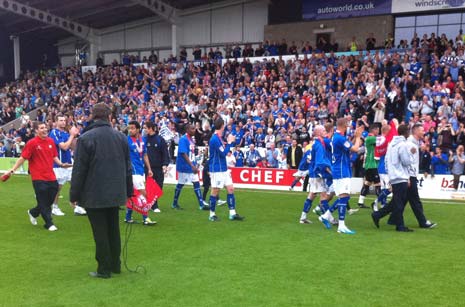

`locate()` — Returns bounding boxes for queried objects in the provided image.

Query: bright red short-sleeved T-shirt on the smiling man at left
[21,136,58,181]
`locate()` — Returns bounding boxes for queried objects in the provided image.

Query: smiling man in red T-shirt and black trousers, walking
[7,122,71,231]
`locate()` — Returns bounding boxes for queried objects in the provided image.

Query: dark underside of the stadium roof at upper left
[0,0,226,40]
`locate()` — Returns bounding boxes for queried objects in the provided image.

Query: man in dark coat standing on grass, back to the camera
[70,103,133,278]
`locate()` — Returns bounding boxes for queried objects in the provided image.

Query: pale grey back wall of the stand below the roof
[58,0,268,64]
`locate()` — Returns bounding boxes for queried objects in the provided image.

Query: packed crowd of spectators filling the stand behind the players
[0,33,465,175]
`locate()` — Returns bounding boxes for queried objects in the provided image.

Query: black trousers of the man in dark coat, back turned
[86,207,121,274]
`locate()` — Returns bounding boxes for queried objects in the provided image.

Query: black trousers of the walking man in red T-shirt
[29,180,58,229]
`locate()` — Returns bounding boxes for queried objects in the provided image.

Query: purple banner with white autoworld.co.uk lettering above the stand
[302,0,392,19]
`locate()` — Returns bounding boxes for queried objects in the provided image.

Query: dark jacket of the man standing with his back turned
[70,121,133,208]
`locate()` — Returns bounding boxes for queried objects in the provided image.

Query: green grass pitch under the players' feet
[0,176,465,306]
